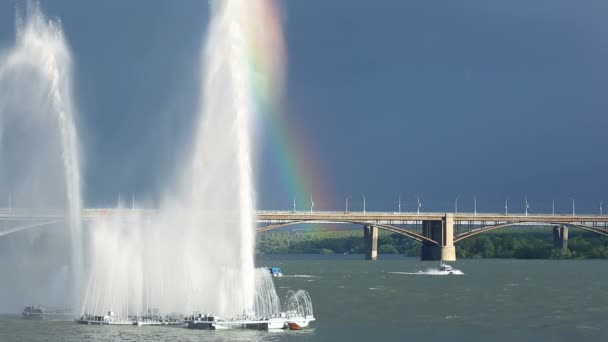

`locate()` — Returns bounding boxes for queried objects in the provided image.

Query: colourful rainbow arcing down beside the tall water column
[240,0,329,219]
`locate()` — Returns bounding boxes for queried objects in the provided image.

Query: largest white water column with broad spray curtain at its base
[81,0,288,317]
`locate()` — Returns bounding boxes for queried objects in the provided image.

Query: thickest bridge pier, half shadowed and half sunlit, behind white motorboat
[420,213,456,261]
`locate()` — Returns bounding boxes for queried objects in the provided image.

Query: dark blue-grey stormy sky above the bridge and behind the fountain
[0,0,608,213]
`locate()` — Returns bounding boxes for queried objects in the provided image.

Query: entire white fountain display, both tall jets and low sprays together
[0,0,314,328]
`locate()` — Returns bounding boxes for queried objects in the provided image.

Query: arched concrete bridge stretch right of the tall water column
[257,211,608,261]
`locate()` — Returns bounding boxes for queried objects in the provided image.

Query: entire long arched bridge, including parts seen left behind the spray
[0,208,608,261]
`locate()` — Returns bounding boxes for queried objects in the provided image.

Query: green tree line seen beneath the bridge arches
[256,228,608,259]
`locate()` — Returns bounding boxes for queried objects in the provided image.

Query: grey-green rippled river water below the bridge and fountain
[0,255,608,342]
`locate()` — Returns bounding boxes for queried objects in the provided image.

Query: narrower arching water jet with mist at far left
[0,3,83,312]
